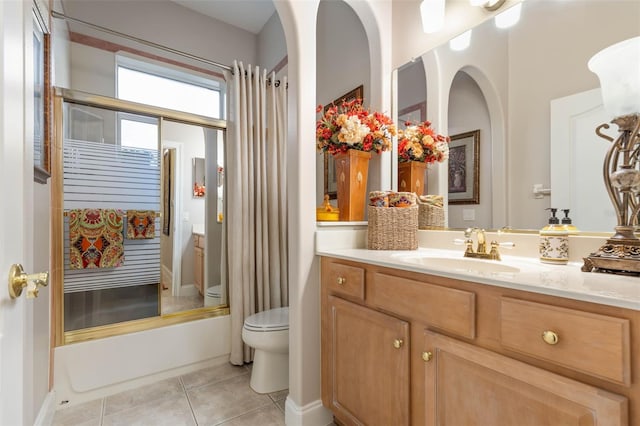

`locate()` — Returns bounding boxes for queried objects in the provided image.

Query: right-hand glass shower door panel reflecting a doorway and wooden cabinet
[161,121,226,314]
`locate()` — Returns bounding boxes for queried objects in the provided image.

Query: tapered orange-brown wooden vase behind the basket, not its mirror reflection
[334,149,371,221]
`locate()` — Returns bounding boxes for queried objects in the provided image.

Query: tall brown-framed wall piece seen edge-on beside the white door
[32,0,52,183]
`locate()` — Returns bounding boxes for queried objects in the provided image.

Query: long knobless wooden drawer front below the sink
[367,273,476,339]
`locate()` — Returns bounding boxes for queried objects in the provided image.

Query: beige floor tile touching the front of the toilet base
[187,374,275,426]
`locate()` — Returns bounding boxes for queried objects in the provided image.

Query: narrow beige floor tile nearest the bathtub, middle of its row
[104,377,184,416]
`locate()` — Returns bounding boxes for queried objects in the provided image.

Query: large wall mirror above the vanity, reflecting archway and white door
[396,0,640,232]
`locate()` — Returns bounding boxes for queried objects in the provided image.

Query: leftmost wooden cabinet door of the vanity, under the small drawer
[322,296,409,426]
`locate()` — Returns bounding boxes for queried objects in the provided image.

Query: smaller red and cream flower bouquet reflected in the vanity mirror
[398,121,451,163]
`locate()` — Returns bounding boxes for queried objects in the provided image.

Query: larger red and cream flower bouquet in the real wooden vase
[316,99,396,155]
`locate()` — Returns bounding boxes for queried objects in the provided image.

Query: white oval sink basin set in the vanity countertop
[397,253,520,275]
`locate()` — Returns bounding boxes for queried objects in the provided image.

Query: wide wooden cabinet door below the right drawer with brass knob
[423,331,628,426]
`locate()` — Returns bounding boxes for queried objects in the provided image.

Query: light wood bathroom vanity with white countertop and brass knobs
[318,249,640,426]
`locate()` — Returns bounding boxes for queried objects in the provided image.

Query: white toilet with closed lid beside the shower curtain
[242,307,289,393]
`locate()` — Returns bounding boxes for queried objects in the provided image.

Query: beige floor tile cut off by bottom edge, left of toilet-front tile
[102,395,196,426]
